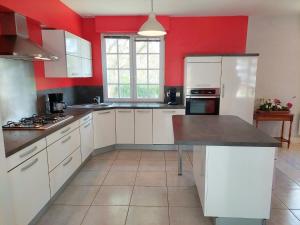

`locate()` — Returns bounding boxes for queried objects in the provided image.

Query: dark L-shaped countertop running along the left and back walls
[3,103,184,157]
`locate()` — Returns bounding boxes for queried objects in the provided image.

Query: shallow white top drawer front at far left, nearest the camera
[7,138,46,171]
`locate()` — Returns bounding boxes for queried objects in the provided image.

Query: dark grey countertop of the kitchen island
[173,115,281,147]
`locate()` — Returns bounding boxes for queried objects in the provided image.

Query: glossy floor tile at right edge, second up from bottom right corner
[274,190,300,209]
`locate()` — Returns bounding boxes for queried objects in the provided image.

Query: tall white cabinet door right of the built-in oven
[220,57,257,124]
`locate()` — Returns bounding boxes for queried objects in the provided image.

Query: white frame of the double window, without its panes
[100,33,165,102]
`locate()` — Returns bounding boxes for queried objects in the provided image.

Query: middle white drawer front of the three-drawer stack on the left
[47,129,80,171]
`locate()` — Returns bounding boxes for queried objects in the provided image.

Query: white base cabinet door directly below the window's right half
[134,109,153,144]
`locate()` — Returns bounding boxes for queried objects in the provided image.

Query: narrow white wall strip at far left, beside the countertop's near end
[0,110,12,225]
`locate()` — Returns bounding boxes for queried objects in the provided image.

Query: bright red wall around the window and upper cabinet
[0,0,248,90]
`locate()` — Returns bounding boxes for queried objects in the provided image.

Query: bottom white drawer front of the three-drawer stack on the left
[49,148,81,197]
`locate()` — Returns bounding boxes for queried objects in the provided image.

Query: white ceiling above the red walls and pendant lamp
[61,0,300,17]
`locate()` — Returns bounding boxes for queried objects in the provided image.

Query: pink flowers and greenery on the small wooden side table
[257,98,293,114]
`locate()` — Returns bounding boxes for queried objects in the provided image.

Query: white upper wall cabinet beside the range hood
[42,30,92,78]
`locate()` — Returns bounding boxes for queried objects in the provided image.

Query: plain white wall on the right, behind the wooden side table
[247,16,300,140]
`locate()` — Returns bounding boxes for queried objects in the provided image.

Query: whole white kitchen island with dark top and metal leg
[173,115,280,225]
